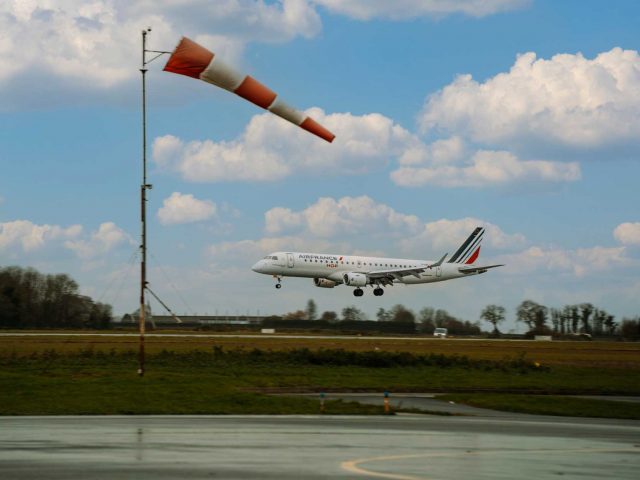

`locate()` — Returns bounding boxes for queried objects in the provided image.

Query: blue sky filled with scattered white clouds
[0,0,640,330]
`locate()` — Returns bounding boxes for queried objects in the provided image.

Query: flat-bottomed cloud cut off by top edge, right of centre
[313,0,529,20]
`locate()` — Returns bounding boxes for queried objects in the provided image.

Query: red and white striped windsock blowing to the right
[164,37,335,142]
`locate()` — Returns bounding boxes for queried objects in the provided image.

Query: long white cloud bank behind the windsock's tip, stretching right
[153,108,581,187]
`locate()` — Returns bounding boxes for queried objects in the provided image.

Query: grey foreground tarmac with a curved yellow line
[0,415,640,480]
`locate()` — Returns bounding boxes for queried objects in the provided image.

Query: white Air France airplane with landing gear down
[251,227,504,297]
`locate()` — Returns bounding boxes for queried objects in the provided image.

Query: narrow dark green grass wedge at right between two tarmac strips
[438,393,640,420]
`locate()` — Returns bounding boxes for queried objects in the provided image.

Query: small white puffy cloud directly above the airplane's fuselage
[265,196,422,237]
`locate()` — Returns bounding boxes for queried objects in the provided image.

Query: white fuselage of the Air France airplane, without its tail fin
[252,252,475,285]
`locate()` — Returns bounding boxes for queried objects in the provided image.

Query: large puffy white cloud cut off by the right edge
[419,48,640,149]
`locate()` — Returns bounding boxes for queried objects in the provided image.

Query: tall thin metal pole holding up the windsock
[138,29,151,377]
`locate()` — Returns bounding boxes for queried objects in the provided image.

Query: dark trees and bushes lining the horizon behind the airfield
[0,267,640,339]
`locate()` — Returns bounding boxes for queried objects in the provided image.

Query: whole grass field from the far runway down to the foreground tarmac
[0,336,640,418]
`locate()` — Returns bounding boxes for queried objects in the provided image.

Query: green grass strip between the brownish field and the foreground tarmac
[0,347,640,415]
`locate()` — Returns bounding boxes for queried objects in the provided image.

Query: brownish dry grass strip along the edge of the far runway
[0,331,640,370]
